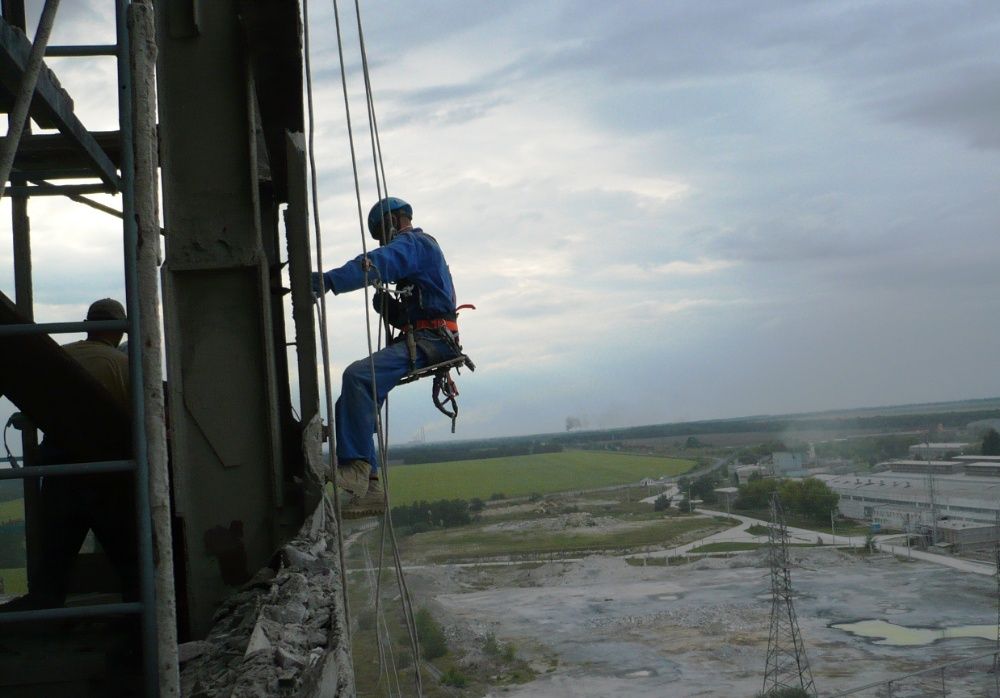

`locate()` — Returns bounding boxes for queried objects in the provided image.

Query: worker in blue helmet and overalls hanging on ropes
[312,197,462,518]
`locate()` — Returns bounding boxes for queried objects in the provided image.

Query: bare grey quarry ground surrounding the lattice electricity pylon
[356,492,997,698]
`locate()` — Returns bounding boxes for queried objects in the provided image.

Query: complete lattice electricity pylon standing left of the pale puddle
[763,492,816,696]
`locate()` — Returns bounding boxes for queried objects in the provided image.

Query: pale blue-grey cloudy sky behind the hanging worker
[0,0,1000,442]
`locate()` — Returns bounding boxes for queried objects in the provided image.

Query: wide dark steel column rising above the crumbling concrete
[155,0,286,637]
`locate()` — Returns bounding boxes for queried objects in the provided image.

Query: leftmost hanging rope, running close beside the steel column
[302,0,353,660]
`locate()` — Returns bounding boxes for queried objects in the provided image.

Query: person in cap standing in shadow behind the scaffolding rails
[0,298,138,611]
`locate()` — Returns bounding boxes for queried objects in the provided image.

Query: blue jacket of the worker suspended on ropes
[323,228,456,327]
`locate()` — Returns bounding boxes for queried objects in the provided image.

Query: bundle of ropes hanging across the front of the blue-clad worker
[333,0,423,696]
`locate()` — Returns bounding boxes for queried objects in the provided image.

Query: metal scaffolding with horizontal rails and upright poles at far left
[0,0,179,696]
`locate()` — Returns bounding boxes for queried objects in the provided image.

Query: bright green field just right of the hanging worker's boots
[389,451,695,505]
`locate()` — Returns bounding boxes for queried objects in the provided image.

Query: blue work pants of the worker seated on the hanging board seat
[335,330,458,474]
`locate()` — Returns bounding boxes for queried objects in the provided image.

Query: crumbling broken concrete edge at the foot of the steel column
[179,494,356,698]
